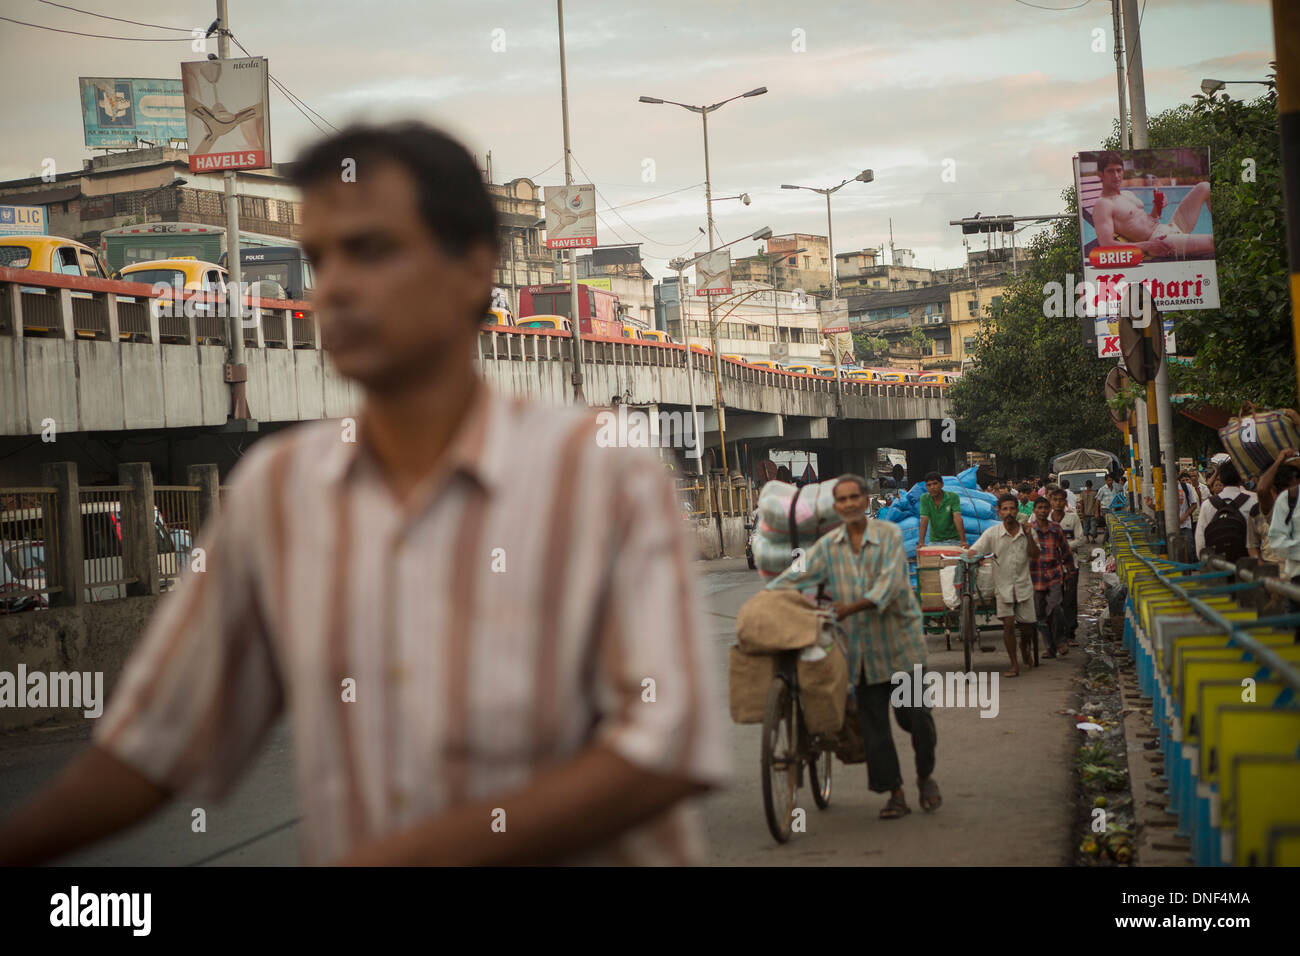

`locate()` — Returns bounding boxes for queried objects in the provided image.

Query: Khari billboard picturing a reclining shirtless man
[1074,147,1219,315]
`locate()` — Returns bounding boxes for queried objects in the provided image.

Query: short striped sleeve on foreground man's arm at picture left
[94,442,283,797]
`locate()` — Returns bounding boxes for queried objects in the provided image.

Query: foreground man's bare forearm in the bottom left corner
[0,744,169,866]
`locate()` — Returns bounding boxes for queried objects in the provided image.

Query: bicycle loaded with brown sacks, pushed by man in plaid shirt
[762,608,839,843]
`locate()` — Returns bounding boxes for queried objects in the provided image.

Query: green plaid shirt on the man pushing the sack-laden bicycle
[767,519,926,684]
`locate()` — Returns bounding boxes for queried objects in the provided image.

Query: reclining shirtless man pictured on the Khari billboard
[1092,152,1214,259]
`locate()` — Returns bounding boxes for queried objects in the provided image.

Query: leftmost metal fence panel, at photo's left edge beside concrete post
[0,488,62,614]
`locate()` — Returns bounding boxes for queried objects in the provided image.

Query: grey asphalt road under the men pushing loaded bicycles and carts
[0,559,1083,866]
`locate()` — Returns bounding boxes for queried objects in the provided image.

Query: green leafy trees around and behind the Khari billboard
[949,88,1296,468]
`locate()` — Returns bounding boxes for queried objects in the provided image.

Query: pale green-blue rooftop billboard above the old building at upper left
[77,77,185,147]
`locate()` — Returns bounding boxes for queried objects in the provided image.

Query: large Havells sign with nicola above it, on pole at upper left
[181,56,270,173]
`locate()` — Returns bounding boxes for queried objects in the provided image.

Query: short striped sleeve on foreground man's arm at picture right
[595,449,731,786]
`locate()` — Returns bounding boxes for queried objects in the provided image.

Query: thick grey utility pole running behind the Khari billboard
[1125,0,1179,554]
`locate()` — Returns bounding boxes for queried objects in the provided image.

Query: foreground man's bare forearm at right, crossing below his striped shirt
[342,744,705,866]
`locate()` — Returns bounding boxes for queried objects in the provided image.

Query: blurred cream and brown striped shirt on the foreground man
[96,382,729,864]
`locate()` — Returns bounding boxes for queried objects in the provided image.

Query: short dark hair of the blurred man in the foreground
[293,122,499,259]
